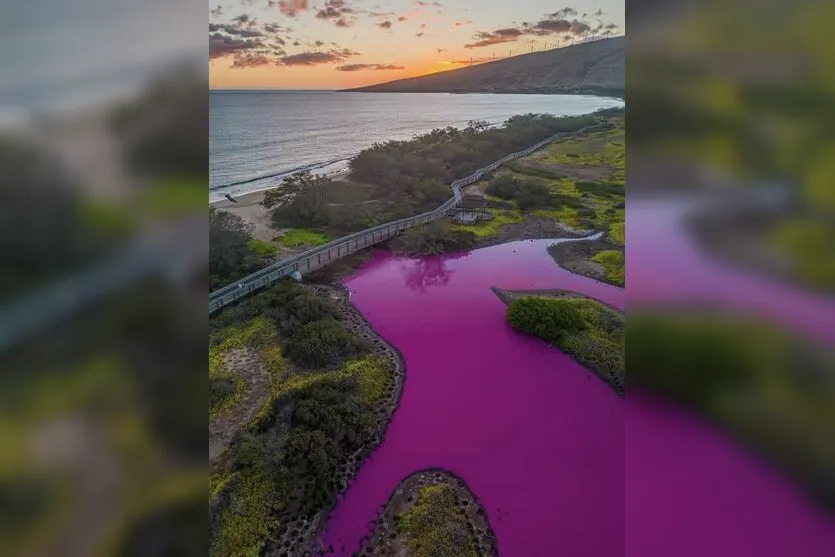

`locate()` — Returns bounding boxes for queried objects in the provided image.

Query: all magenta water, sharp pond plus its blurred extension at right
[326,202,835,557]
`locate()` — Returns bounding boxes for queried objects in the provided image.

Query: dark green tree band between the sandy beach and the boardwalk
[263,111,622,237]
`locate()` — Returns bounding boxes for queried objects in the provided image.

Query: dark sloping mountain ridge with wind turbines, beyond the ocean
[341,36,625,97]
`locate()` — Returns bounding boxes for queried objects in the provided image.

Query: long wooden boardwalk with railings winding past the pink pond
[209,122,611,314]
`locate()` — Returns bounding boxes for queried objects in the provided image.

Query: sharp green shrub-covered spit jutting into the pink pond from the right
[507,296,624,393]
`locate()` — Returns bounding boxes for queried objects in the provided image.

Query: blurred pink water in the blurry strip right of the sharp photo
[625,199,835,557]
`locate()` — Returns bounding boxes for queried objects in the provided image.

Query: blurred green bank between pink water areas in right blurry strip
[627,313,835,507]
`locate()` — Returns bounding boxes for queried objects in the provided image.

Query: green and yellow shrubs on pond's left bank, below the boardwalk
[210,281,393,556]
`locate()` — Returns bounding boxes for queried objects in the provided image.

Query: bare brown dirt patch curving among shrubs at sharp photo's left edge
[209,347,270,462]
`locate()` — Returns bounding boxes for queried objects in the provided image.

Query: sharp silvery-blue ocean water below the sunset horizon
[209,91,623,201]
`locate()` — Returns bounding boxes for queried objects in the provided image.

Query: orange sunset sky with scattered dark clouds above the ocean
[209,0,624,89]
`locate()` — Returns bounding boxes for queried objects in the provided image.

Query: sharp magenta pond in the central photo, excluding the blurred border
[324,237,624,557]
